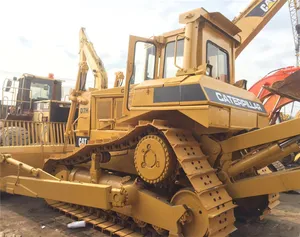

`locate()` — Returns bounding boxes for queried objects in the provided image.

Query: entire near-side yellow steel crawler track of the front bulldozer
[46,120,236,237]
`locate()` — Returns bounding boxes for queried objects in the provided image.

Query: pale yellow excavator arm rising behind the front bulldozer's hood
[79,28,108,89]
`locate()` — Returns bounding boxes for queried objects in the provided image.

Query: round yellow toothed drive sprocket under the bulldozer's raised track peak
[134,135,176,184]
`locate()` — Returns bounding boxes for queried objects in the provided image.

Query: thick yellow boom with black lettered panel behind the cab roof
[233,0,287,58]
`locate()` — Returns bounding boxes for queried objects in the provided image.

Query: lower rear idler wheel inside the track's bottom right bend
[171,189,209,237]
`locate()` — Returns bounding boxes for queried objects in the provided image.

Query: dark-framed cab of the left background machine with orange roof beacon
[1,74,62,121]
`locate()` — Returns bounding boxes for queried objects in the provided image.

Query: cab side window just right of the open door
[163,39,184,78]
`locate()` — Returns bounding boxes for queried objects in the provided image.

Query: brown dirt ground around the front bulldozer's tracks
[0,194,300,237]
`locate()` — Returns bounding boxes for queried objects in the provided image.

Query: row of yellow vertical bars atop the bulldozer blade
[0,120,75,146]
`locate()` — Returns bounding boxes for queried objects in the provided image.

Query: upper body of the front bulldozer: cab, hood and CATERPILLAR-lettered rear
[76,8,267,143]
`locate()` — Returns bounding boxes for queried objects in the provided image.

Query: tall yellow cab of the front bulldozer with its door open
[124,8,240,114]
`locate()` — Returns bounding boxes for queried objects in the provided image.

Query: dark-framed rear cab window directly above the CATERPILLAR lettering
[206,41,229,82]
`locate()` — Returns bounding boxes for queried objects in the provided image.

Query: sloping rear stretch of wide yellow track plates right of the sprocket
[160,127,236,236]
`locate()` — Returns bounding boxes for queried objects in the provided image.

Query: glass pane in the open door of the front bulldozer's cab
[130,42,156,84]
